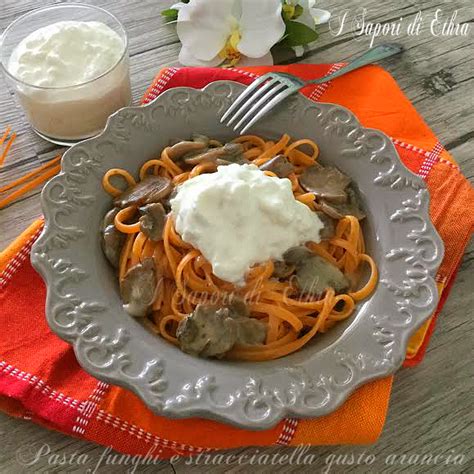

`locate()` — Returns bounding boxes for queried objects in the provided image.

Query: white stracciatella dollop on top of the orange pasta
[171,164,323,285]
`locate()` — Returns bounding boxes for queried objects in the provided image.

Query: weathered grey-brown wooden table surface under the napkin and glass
[0,0,474,473]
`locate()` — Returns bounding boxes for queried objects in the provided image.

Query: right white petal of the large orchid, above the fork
[237,0,285,58]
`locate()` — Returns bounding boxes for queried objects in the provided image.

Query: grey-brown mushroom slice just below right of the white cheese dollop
[284,247,349,296]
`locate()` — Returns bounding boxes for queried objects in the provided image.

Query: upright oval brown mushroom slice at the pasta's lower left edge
[120,258,158,317]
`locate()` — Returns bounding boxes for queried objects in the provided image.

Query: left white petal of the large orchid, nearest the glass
[176,0,234,61]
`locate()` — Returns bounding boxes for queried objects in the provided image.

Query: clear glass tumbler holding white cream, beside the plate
[0,3,132,146]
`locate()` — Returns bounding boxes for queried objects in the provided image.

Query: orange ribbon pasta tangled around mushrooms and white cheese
[103,135,378,361]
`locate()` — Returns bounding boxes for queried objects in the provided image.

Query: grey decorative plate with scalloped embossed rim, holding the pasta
[31,81,443,429]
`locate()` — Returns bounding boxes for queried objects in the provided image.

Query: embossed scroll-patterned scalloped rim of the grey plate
[31,81,444,429]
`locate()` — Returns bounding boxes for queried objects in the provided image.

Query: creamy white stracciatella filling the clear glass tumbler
[8,21,132,140]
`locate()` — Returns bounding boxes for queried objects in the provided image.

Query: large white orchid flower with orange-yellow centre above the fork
[173,0,285,67]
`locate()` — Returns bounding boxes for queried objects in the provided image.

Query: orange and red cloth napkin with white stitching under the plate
[0,64,474,458]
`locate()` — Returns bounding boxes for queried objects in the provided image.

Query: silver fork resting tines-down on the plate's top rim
[221,44,403,135]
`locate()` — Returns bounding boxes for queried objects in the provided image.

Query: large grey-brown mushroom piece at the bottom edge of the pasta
[176,302,266,358]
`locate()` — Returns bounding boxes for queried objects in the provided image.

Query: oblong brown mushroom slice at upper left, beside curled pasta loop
[114,175,173,208]
